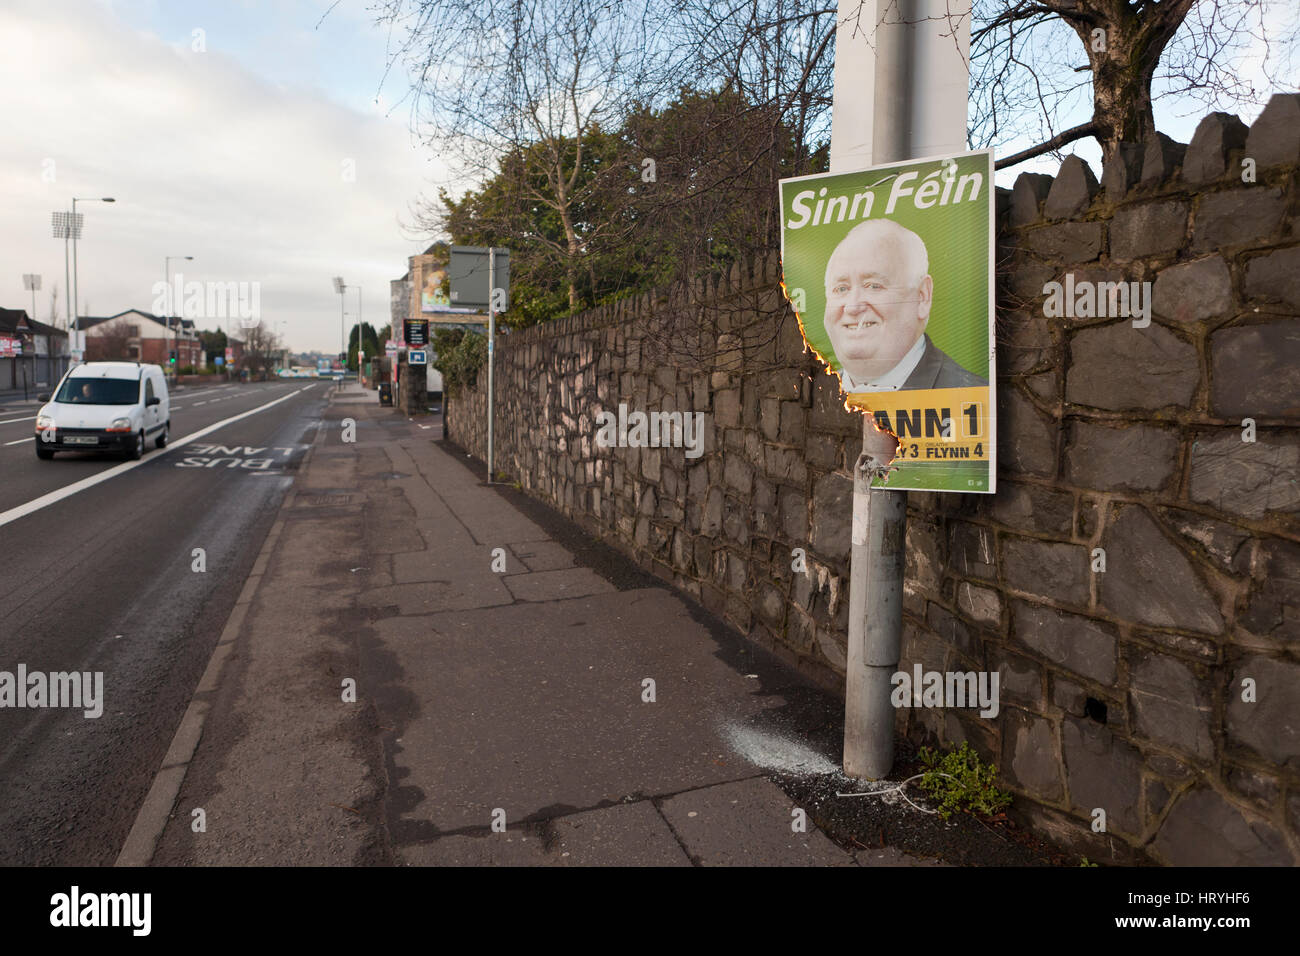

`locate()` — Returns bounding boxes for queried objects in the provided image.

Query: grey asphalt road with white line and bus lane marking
[0,381,332,865]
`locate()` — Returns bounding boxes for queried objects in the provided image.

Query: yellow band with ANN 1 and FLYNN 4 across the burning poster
[849,385,992,463]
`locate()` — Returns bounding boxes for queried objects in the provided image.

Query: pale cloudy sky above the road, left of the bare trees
[0,0,439,351]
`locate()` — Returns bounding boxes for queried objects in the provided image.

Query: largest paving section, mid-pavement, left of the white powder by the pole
[367,588,785,845]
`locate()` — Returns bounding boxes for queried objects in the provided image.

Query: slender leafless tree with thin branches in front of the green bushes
[377,0,676,307]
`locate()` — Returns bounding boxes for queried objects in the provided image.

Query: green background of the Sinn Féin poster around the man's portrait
[780,151,996,493]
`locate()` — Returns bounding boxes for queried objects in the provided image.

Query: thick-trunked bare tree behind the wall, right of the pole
[970,0,1296,168]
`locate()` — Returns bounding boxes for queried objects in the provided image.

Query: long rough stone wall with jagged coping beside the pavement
[449,95,1300,865]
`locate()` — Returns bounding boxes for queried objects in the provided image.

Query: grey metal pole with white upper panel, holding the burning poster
[831,0,971,780]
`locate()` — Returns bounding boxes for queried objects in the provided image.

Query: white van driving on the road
[36,362,172,460]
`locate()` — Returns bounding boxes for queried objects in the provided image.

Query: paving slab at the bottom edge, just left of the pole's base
[660,778,854,866]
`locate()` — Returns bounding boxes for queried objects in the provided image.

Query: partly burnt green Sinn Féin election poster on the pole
[781,151,997,494]
